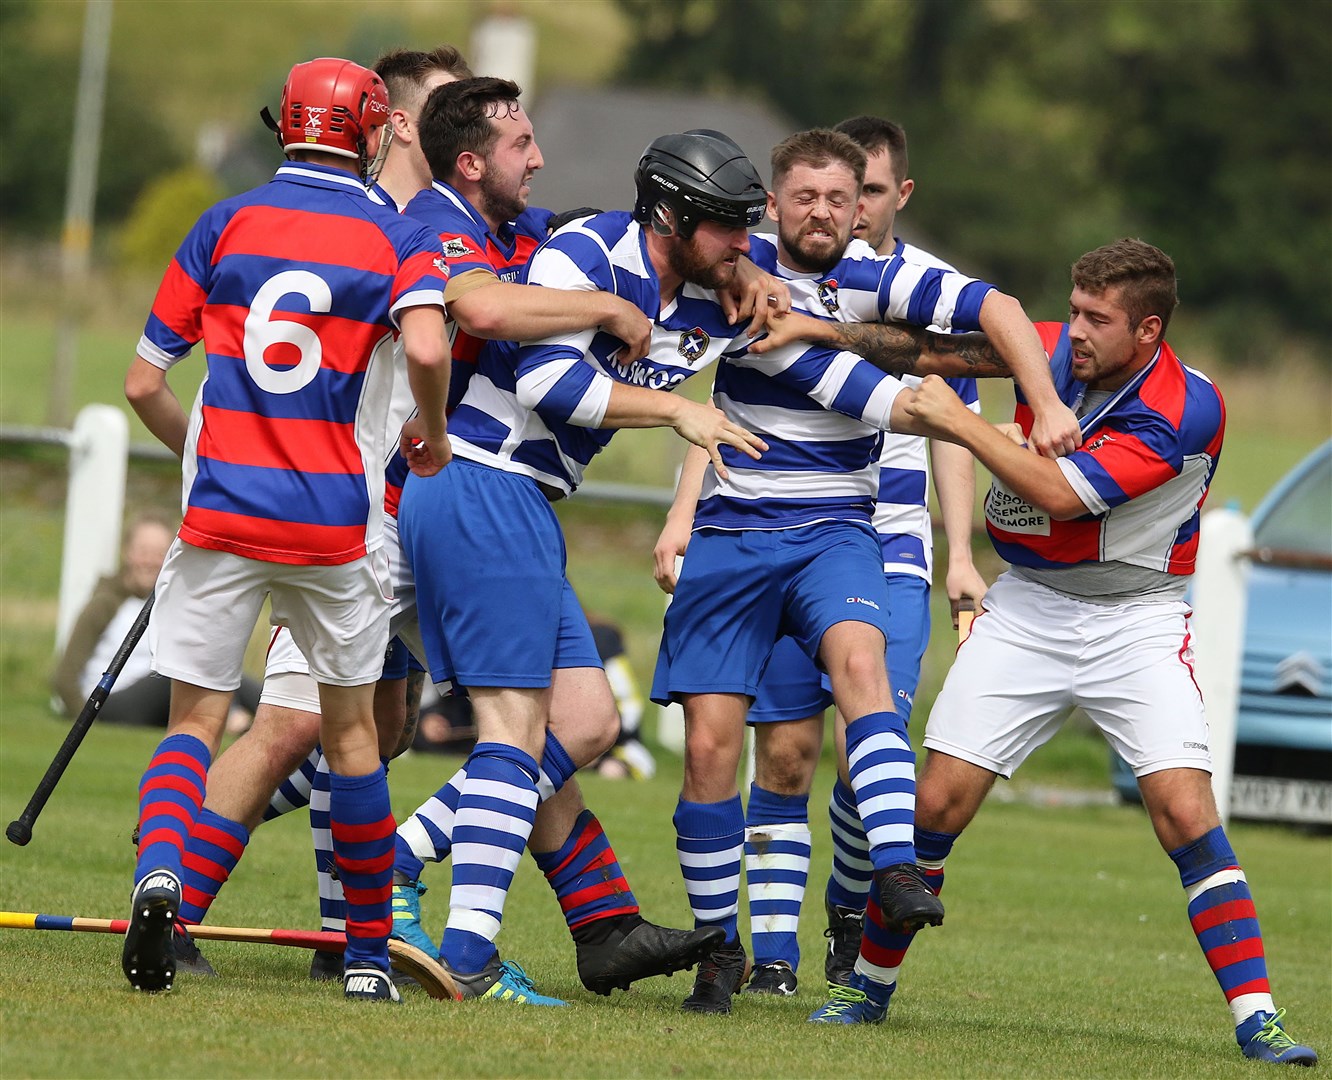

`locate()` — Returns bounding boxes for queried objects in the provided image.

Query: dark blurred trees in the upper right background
[619,0,1332,351]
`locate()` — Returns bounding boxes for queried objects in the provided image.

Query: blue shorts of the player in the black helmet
[398,458,602,687]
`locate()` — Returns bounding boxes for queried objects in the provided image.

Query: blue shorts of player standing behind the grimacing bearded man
[747,574,930,723]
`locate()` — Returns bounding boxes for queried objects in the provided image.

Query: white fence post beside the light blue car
[1192,509,1253,823]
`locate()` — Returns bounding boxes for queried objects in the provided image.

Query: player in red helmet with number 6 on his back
[121,57,450,1000]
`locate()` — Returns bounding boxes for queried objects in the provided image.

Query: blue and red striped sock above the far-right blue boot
[1169,826,1276,1027]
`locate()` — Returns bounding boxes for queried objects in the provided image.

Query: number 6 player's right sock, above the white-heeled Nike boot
[329,764,394,971]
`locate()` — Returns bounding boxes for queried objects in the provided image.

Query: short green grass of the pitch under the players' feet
[0,708,1332,1077]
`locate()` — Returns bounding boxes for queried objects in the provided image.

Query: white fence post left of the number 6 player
[56,405,129,651]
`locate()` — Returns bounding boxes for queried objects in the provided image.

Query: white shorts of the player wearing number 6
[148,538,393,690]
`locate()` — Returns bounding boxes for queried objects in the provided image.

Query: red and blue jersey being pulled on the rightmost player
[986,322,1225,574]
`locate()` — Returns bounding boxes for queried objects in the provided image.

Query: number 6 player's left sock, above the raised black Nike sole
[135,735,212,886]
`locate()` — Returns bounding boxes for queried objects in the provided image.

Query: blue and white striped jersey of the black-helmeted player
[449,210,747,494]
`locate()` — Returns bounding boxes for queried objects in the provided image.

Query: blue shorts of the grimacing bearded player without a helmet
[651,521,888,715]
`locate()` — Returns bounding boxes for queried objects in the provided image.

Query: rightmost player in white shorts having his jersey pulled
[826,238,1317,1065]
